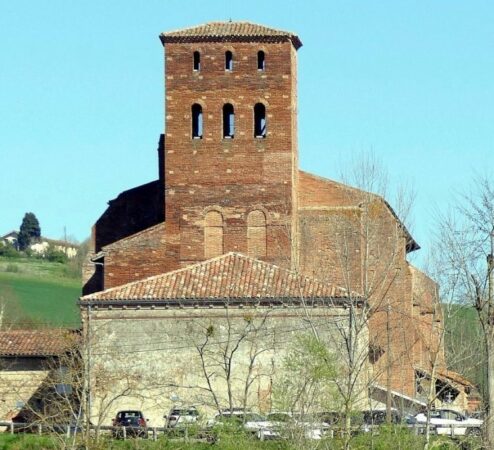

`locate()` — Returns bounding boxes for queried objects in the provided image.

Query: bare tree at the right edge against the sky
[437,177,494,448]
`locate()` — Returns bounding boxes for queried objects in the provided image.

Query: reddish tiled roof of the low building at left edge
[0,328,78,356]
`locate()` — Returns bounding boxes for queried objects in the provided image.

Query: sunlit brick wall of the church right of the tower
[299,172,418,396]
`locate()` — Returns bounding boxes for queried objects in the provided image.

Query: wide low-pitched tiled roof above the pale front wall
[80,253,357,303]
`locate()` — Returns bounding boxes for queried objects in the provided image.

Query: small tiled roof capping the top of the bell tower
[160,22,302,49]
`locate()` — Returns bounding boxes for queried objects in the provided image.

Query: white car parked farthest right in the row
[415,409,483,436]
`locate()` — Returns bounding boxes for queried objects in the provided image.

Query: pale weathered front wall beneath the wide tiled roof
[83,306,368,426]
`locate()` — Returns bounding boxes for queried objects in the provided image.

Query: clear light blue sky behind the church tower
[0,0,494,268]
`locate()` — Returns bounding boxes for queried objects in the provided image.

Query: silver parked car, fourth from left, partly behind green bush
[260,412,330,440]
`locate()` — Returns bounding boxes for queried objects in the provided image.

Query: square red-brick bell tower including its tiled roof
[160,22,302,267]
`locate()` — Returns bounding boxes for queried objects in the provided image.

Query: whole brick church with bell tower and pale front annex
[80,22,473,425]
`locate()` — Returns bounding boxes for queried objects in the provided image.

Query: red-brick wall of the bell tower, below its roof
[165,42,297,266]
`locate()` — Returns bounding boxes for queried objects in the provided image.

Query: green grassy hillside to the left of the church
[0,257,81,328]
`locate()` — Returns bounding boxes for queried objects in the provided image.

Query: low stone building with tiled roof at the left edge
[0,329,79,420]
